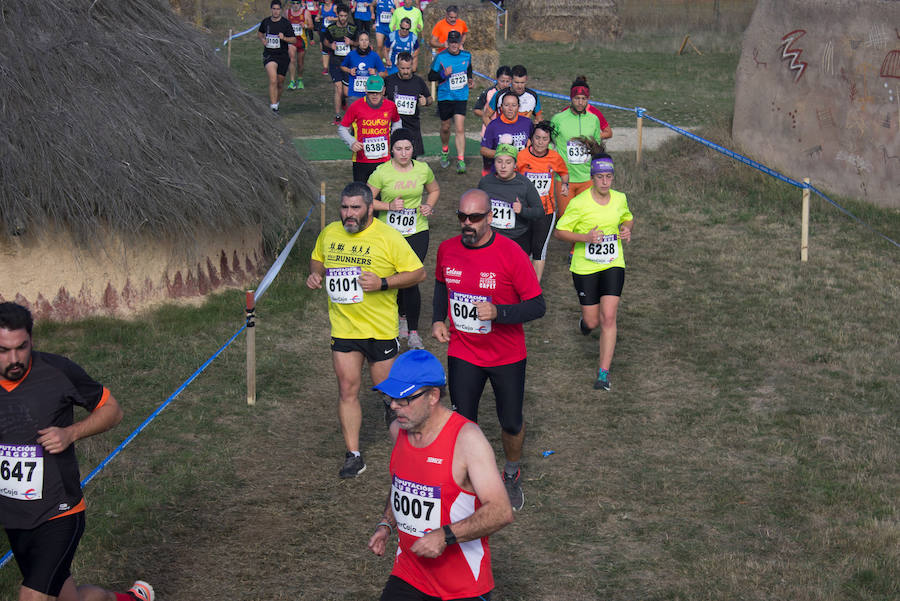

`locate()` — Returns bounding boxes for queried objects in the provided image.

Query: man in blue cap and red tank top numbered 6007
[368,350,513,601]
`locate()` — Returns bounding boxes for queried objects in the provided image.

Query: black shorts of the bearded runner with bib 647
[6,511,84,597]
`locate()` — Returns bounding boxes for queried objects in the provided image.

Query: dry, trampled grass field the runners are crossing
[0,2,900,601]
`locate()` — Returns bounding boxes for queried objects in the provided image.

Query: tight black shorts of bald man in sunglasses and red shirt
[447,357,526,435]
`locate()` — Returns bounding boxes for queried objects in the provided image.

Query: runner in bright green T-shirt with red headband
[550,79,612,217]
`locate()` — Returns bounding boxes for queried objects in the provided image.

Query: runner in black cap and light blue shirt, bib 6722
[428,31,474,173]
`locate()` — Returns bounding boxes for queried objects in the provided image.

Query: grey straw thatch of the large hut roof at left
[0,0,317,243]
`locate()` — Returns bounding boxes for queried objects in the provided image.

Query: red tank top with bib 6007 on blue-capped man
[390,412,494,599]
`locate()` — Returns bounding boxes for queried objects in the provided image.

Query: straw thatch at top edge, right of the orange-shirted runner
[506,0,622,42]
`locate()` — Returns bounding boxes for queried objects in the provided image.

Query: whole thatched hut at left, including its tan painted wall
[0,0,318,319]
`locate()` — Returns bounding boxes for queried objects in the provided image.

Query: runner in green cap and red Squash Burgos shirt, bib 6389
[338,75,400,182]
